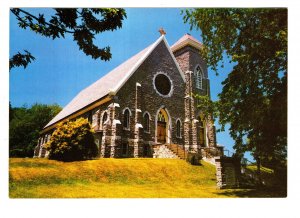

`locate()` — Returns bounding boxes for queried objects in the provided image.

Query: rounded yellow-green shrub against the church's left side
[45,118,98,161]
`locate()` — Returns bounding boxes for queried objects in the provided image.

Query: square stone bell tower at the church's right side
[171,34,216,152]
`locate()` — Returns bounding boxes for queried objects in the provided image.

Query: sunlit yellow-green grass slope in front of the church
[9,158,284,198]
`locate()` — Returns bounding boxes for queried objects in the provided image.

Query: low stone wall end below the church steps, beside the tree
[215,156,241,189]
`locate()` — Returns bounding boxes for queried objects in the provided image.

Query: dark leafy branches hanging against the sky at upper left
[9,8,126,69]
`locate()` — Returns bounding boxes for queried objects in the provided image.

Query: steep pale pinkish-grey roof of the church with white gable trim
[44,36,185,129]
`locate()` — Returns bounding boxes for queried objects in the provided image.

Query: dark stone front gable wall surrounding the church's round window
[116,39,185,154]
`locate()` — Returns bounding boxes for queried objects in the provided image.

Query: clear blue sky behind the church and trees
[9,8,239,156]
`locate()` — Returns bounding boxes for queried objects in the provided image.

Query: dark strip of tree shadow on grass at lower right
[215,189,287,198]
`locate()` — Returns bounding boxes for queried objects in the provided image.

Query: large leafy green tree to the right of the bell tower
[184,8,287,176]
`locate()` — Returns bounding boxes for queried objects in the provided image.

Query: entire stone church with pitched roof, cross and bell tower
[34,29,222,159]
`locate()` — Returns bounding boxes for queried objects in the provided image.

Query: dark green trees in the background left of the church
[9,104,61,157]
